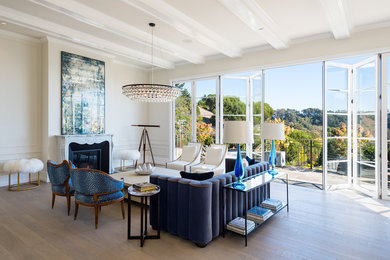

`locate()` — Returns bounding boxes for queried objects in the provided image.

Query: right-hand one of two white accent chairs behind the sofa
[190,144,228,176]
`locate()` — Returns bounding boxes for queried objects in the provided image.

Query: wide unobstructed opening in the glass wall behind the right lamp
[264,62,323,187]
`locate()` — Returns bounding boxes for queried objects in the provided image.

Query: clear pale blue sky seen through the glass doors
[181,56,374,110]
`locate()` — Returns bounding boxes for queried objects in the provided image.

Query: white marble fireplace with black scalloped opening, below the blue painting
[57,134,113,173]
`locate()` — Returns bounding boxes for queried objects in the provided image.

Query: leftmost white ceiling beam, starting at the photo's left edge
[0,5,174,69]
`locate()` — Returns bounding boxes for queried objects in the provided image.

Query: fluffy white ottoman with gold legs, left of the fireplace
[4,158,43,191]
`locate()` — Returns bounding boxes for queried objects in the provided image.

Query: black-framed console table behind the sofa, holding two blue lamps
[222,172,289,246]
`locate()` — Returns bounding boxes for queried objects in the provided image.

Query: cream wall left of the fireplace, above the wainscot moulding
[0,33,42,186]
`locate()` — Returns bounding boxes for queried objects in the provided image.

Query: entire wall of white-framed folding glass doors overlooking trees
[171,54,384,199]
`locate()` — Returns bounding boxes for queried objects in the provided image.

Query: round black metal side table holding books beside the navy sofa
[127,186,160,247]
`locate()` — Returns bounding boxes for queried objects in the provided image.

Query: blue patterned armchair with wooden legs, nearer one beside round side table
[70,168,125,228]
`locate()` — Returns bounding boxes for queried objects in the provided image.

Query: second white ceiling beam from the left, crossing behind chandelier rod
[29,0,204,64]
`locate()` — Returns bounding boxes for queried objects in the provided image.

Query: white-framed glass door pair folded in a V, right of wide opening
[323,56,380,197]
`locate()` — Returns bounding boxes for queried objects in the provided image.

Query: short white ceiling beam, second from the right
[219,0,290,50]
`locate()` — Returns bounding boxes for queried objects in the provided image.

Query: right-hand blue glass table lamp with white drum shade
[261,123,284,175]
